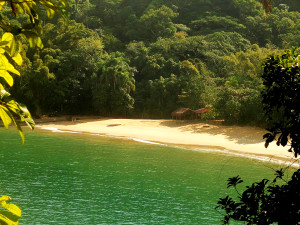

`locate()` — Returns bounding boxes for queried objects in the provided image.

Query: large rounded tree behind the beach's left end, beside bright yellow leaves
[28,19,104,115]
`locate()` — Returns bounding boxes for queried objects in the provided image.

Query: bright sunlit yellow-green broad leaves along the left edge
[0,0,67,225]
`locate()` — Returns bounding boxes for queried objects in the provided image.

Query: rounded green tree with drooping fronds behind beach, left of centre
[92,52,135,116]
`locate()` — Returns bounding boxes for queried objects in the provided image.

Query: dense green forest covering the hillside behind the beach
[2,0,300,124]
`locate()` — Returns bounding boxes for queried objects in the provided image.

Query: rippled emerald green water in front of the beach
[0,129,284,225]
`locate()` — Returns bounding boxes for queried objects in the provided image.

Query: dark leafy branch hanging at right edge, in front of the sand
[262,49,300,157]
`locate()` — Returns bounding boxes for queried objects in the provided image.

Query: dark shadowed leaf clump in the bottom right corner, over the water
[216,170,300,224]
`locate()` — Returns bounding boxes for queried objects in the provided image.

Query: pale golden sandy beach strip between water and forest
[37,117,294,162]
